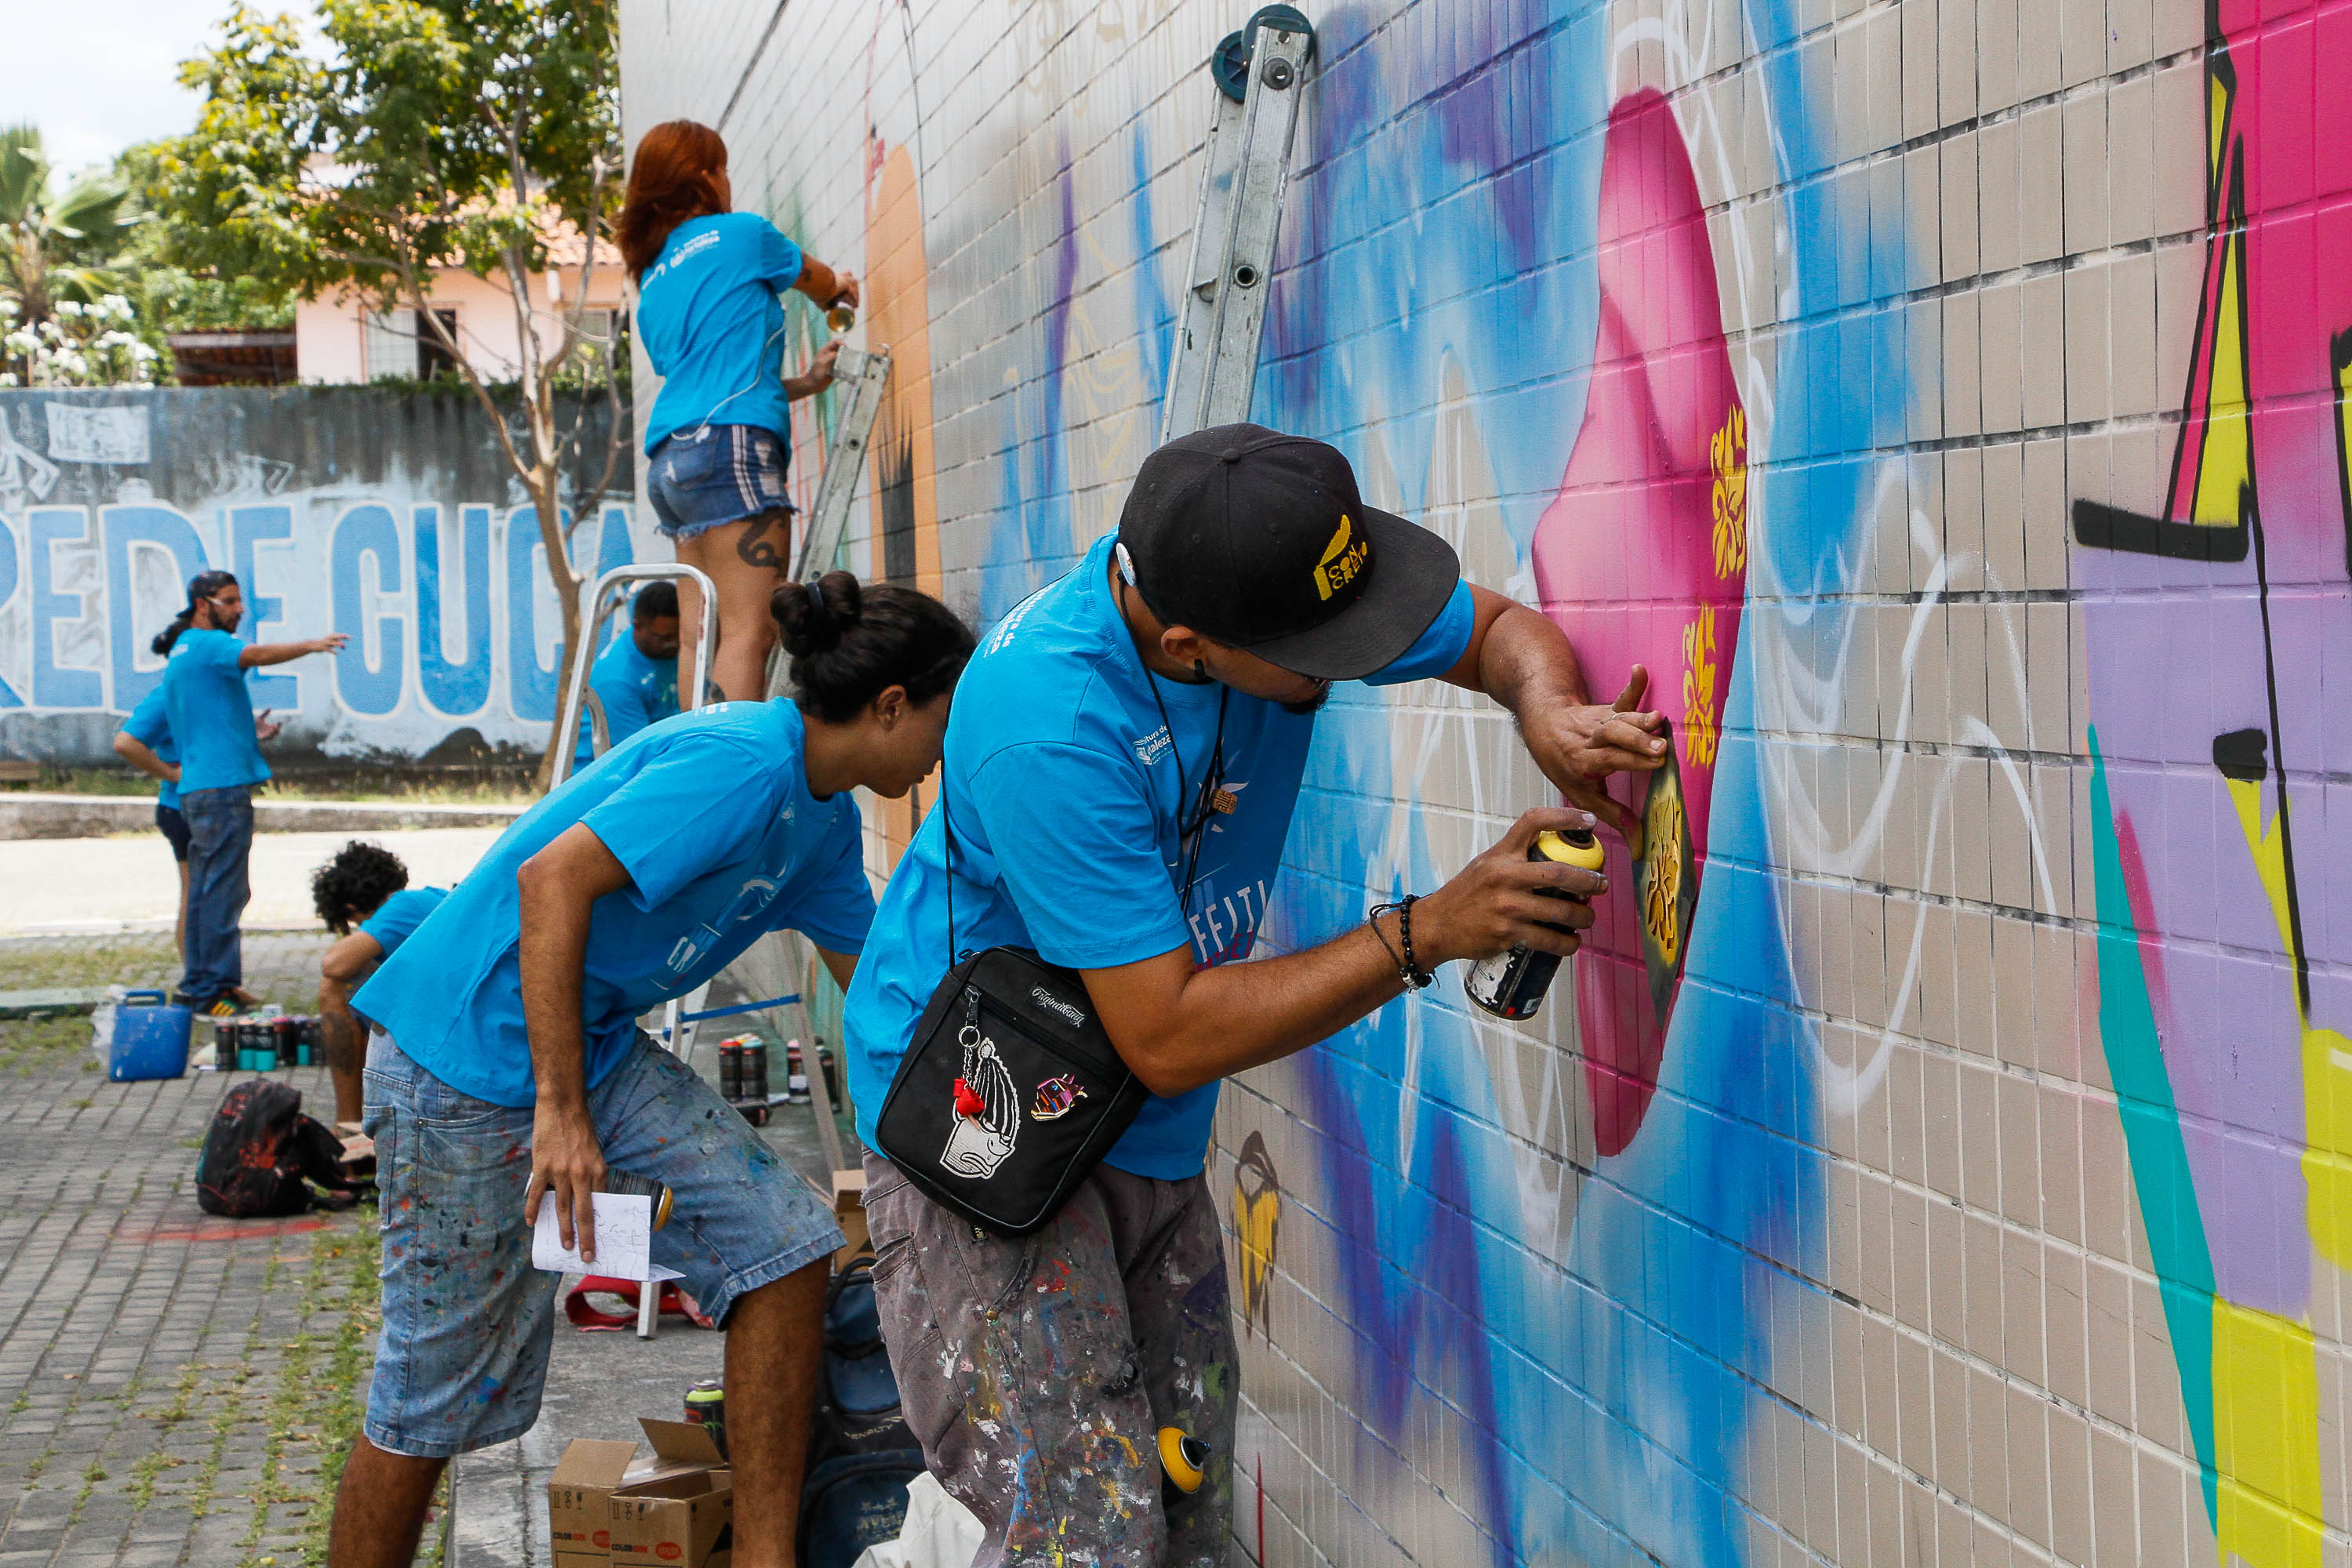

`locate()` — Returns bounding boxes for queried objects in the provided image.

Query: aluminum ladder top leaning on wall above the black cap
[1160,5,1315,445]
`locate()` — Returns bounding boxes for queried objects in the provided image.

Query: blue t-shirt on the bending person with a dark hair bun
[353,701,875,1105]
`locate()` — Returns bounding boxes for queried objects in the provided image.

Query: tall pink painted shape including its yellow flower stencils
[1531,89,1748,1154]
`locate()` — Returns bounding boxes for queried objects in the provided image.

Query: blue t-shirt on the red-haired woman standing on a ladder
[637,212,802,454]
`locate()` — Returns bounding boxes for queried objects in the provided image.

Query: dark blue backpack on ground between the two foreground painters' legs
[800,1258,922,1568]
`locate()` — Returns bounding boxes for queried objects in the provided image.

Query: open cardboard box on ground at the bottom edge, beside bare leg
[548,1417,734,1568]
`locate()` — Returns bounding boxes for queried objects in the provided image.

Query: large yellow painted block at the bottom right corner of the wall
[2213,1298,2321,1568]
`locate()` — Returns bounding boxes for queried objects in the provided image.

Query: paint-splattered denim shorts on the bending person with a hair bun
[365,1034,842,1457]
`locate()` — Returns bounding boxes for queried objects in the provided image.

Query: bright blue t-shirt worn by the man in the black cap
[842,539,1475,1180]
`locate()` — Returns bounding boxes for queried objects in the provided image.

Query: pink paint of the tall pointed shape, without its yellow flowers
[1534,87,1745,1154]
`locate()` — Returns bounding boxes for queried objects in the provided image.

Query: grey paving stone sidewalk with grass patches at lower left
[0,933,374,1568]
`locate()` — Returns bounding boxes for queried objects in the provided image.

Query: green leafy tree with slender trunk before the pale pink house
[148,0,628,785]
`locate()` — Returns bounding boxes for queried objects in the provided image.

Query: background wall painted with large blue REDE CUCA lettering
[0,388,644,764]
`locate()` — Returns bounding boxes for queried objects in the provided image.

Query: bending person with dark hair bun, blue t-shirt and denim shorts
[329,572,971,1568]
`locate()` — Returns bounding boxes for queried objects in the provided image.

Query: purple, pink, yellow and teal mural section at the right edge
[2074,0,2352,1566]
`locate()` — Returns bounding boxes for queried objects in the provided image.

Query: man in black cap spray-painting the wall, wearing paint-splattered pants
[844,426,1665,1568]
